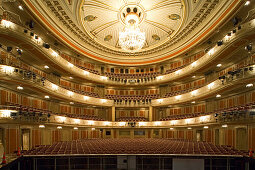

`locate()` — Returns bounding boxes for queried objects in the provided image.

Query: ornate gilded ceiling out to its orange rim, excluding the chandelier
[23,0,240,65]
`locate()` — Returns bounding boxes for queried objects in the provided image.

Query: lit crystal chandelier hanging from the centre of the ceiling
[119,13,145,52]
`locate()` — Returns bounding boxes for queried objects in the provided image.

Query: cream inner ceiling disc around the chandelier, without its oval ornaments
[81,0,184,50]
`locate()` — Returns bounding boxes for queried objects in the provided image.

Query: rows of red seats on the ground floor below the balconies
[24,138,247,157]
